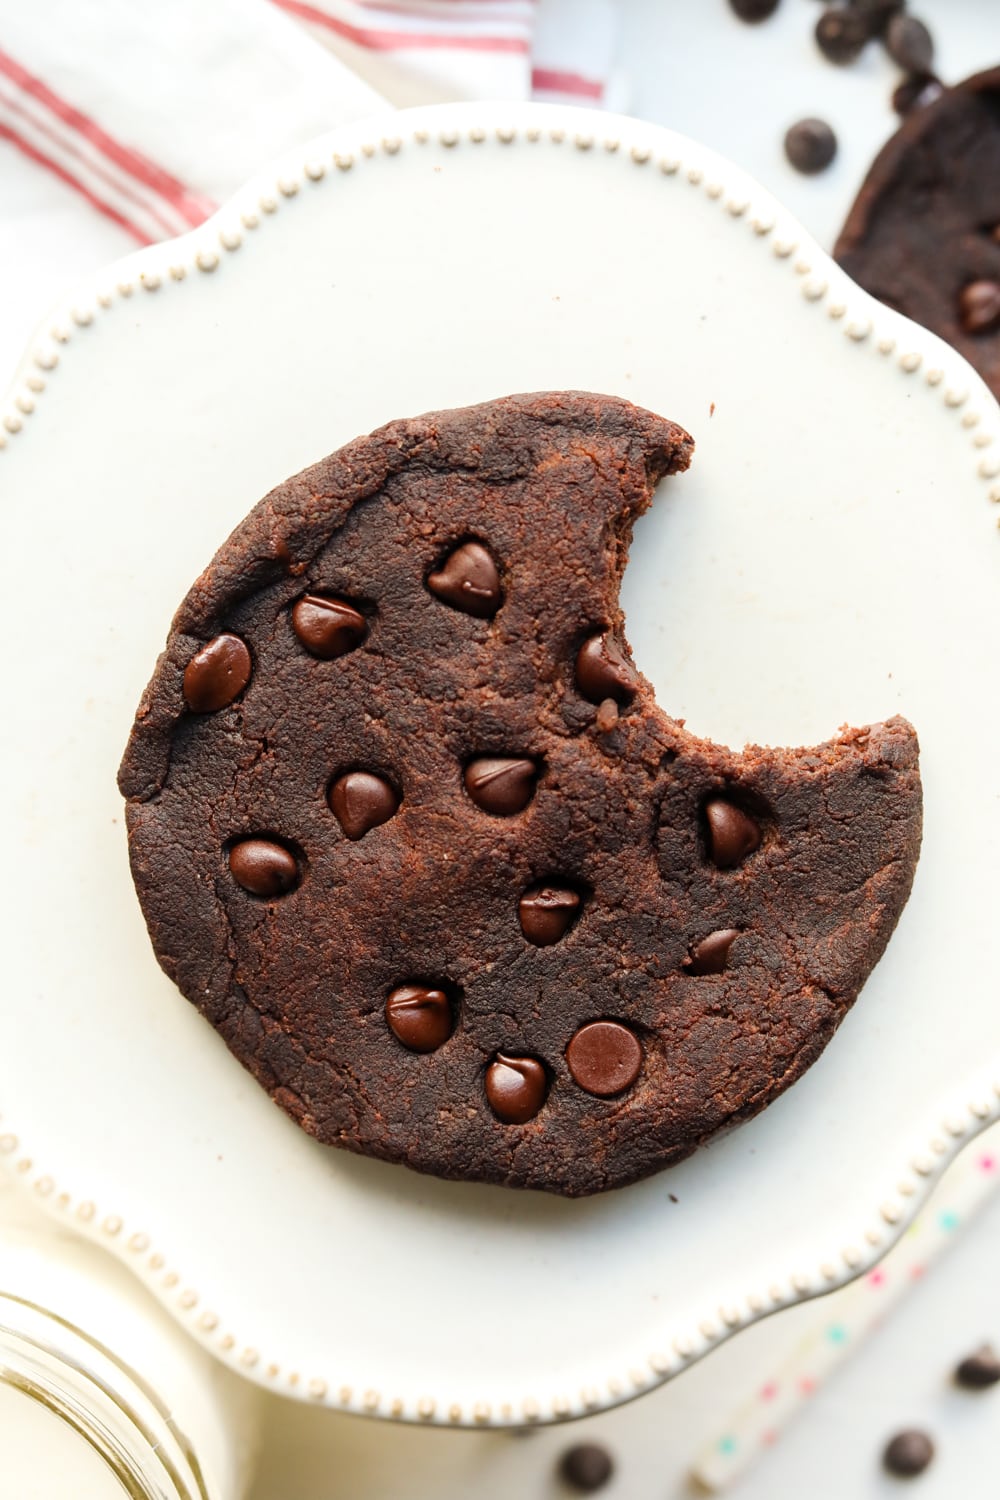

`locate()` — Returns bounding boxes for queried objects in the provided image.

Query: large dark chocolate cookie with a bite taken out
[120,395,921,1194]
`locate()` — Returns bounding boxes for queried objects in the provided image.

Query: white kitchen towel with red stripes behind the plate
[0,0,621,249]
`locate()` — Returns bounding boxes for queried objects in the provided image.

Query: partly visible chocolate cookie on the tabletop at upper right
[834,69,1000,398]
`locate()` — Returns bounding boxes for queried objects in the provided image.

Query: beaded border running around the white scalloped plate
[0,114,1000,1428]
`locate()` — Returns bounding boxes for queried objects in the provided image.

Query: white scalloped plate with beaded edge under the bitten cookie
[0,105,1000,1425]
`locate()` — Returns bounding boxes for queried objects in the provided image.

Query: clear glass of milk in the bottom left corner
[0,1178,259,1500]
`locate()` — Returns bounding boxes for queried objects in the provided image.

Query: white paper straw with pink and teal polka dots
[693,1130,1000,1493]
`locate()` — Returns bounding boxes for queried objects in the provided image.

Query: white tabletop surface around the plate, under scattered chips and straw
[0,0,1000,1500]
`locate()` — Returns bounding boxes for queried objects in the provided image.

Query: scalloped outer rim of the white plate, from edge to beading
[0,104,1000,1428]
